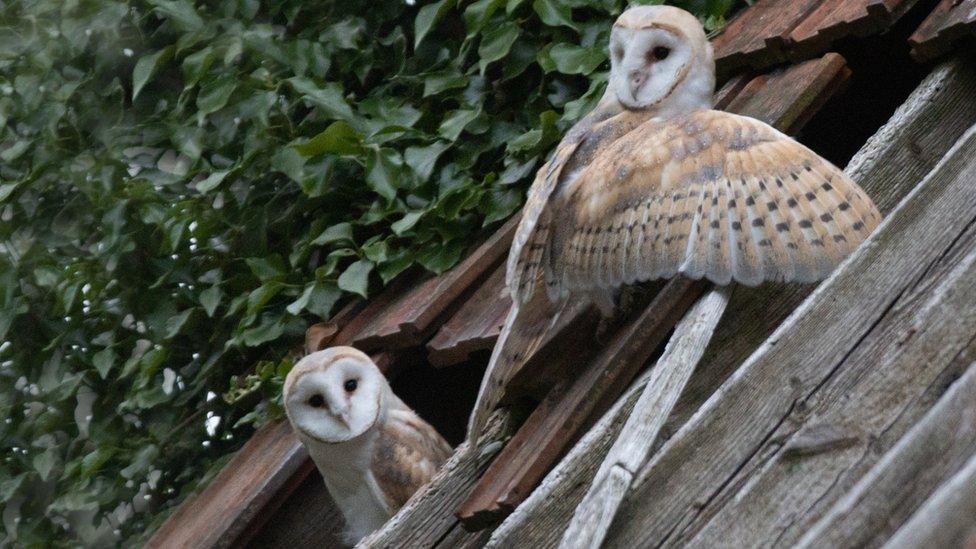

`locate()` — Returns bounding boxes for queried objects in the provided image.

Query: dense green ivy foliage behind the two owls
[0,0,731,545]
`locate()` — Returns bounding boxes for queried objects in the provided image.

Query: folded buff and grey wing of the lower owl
[370,407,453,513]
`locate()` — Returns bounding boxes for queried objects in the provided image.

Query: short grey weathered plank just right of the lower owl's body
[360,410,511,548]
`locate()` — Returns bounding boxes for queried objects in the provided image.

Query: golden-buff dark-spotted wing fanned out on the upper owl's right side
[546,110,881,295]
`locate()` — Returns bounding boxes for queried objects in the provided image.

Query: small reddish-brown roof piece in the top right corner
[908,0,976,61]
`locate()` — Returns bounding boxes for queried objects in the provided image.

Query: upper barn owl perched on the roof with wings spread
[468,6,880,446]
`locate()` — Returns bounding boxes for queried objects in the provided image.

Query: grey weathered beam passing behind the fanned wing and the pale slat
[488,53,976,547]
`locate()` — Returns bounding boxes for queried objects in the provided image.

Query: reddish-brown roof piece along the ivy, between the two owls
[352,215,519,352]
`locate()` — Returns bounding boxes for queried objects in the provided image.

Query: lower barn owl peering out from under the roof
[284,347,452,543]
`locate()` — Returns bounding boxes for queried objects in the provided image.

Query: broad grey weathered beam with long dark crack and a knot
[608,128,976,546]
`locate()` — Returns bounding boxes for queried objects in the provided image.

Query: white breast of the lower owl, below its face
[299,430,392,543]
